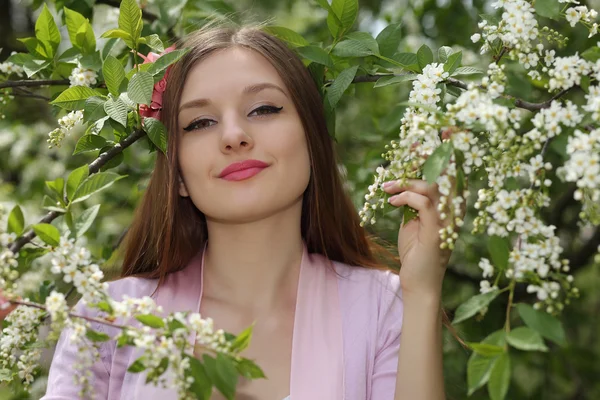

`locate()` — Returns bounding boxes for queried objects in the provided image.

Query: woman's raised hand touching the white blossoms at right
[383,179,452,298]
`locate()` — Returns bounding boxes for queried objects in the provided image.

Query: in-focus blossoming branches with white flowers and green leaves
[0,0,600,399]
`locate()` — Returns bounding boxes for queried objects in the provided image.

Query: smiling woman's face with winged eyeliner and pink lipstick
[178,47,310,223]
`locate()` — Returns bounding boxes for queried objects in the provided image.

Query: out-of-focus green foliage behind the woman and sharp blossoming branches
[0,0,600,400]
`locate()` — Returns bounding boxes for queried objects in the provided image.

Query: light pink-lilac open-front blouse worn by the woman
[42,245,403,400]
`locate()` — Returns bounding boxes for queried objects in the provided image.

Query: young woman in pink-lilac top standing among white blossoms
[1,22,449,400]
